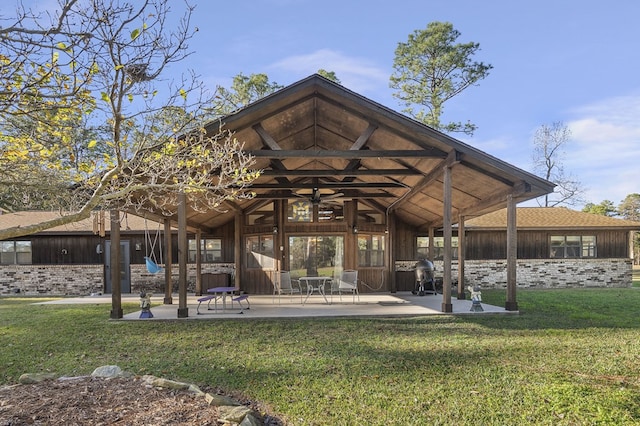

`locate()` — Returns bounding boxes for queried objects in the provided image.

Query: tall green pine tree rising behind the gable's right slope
[390,22,493,135]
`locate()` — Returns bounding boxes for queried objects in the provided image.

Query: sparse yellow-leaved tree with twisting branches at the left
[0,0,257,240]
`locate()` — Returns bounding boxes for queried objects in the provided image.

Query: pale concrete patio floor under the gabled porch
[44,292,518,321]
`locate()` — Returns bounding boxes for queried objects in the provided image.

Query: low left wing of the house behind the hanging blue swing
[0,211,233,295]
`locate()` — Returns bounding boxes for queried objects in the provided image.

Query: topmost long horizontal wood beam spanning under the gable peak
[245,149,444,160]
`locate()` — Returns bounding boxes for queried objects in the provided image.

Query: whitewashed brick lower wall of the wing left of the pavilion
[0,263,234,296]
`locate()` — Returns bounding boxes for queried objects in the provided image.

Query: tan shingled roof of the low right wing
[465,207,640,231]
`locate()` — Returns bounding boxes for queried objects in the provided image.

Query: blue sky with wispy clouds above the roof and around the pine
[180,0,640,208]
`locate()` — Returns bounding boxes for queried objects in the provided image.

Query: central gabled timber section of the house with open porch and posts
[0,75,554,316]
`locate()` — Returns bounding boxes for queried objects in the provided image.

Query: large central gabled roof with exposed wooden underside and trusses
[149,74,554,232]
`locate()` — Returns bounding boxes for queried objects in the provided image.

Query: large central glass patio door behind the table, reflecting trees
[289,235,344,278]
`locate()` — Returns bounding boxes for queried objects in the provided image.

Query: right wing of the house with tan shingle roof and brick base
[454,207,640,288]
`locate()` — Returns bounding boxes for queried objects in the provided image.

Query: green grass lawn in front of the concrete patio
[0,283,640,425]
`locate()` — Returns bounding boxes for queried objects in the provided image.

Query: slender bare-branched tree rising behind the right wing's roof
[533,122,584,207]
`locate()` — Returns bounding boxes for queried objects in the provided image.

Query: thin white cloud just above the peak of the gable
[270,49,389,93]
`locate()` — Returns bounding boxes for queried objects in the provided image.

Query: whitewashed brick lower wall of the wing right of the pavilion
[396,259,633,288]
